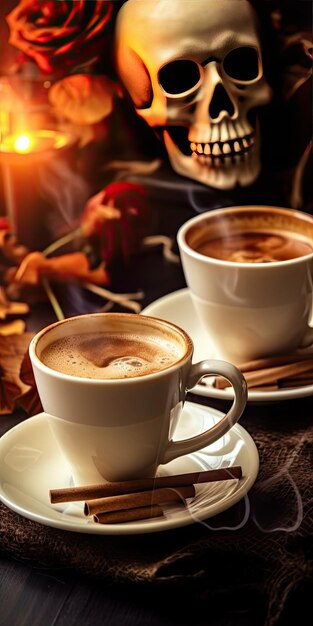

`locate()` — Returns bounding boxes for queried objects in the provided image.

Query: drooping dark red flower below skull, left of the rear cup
[81,182,150,264]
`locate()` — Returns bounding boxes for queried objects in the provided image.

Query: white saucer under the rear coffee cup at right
[141,288,313,402]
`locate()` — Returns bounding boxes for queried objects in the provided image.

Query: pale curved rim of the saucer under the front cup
[0,408,259,535]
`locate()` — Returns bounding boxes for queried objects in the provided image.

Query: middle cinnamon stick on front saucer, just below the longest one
[84,485,196,515]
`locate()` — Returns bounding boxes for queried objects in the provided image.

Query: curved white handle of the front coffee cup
[162,360,248,463]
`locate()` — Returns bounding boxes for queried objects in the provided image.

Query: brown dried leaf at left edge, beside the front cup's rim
[0,333,33,414]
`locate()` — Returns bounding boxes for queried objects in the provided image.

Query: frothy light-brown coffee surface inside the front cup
[41,332,184,379]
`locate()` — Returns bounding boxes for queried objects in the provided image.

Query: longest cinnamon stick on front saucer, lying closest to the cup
[49,465,242,504]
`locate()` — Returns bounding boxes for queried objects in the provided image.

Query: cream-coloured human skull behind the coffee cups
[115,0,271,189]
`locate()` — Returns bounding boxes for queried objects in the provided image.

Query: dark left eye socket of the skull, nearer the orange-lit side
[158,59,201,96]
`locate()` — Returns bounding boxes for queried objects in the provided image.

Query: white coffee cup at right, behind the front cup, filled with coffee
[177,206,313,365]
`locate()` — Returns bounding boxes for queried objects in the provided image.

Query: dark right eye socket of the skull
[223,46,260,83]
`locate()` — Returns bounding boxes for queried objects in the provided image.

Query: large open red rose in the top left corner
[6,0,113,74]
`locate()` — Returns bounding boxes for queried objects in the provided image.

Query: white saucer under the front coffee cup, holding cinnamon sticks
[0,402,259,535]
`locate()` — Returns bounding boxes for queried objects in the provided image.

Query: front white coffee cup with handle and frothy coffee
[29,313,247,485]
